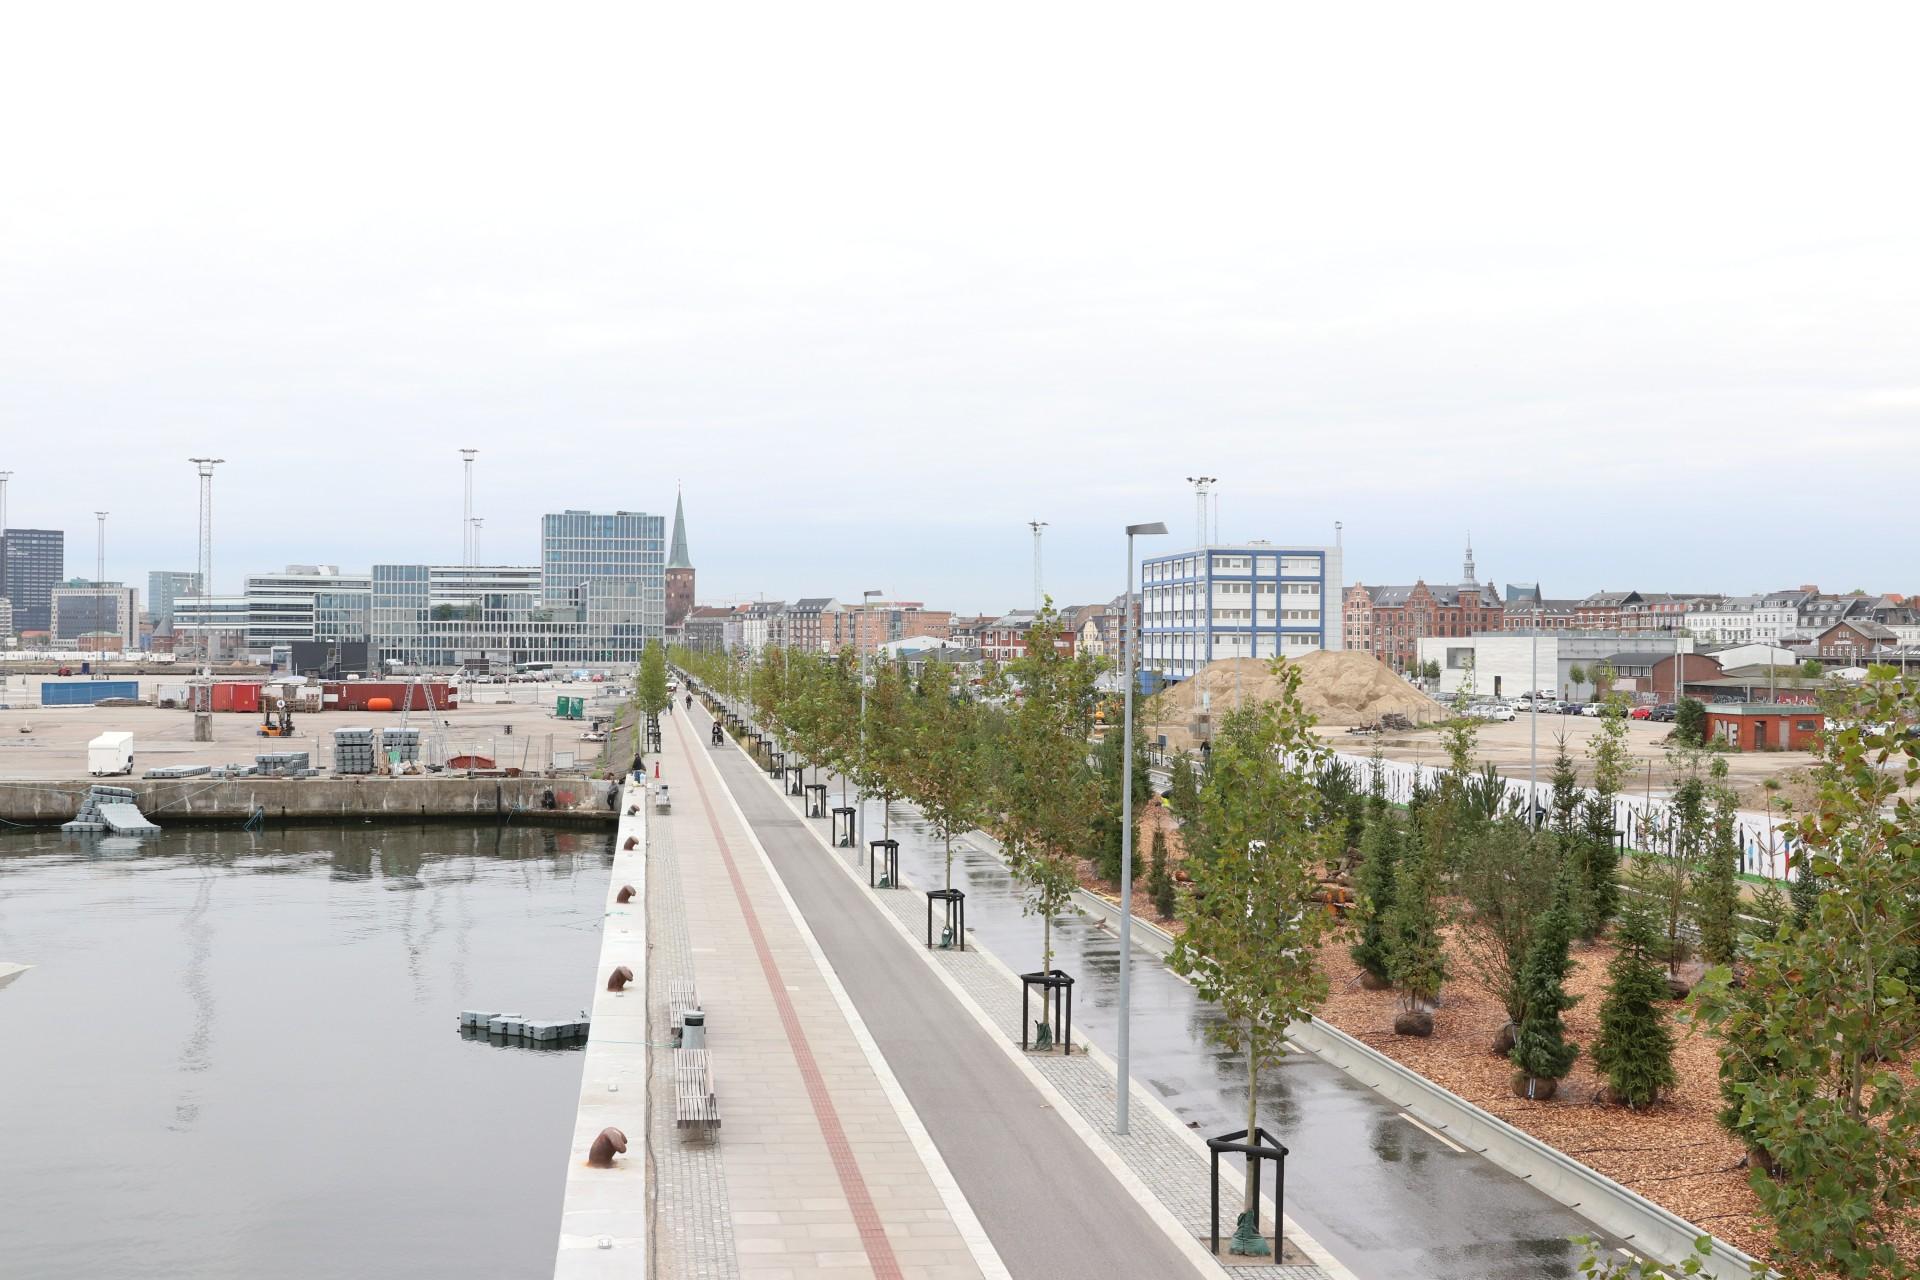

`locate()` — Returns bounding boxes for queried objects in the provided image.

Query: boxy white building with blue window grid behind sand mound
[1140,541,1342,679]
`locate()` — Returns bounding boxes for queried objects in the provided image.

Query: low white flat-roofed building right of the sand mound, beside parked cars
[1419,629,1695,700]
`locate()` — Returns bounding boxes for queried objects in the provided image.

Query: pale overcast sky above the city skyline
[0,2,1920,610]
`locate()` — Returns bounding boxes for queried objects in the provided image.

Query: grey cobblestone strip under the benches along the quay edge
[647,794,739,1280]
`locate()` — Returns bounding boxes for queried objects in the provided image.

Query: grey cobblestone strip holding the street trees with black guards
[741,759,1334,1280]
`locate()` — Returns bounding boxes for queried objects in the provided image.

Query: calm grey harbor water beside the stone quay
[0,825,612,1280]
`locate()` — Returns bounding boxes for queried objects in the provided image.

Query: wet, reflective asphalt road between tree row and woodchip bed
[701,712,1619,1280]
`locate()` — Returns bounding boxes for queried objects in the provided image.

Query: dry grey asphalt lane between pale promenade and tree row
[691,712,1192,1280]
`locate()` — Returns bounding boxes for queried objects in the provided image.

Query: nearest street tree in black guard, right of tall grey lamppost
[1169,660,1332,1255]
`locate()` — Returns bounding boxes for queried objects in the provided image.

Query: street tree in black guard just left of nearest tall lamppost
[995,601,1100,1046]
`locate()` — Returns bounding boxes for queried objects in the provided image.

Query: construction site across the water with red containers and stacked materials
[0,676,630,823]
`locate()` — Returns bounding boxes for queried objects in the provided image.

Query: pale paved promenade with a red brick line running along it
[649,714,1006,1280]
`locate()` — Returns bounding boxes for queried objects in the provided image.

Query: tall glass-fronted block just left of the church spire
[540,510,666,644]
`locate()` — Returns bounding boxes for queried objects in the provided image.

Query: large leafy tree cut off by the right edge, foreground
[1693,681,1920,1280]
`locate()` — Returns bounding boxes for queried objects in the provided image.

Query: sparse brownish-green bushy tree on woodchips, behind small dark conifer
[1453,819,1559,1054]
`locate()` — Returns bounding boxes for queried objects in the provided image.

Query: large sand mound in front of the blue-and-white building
[1146,651,1448,750]
